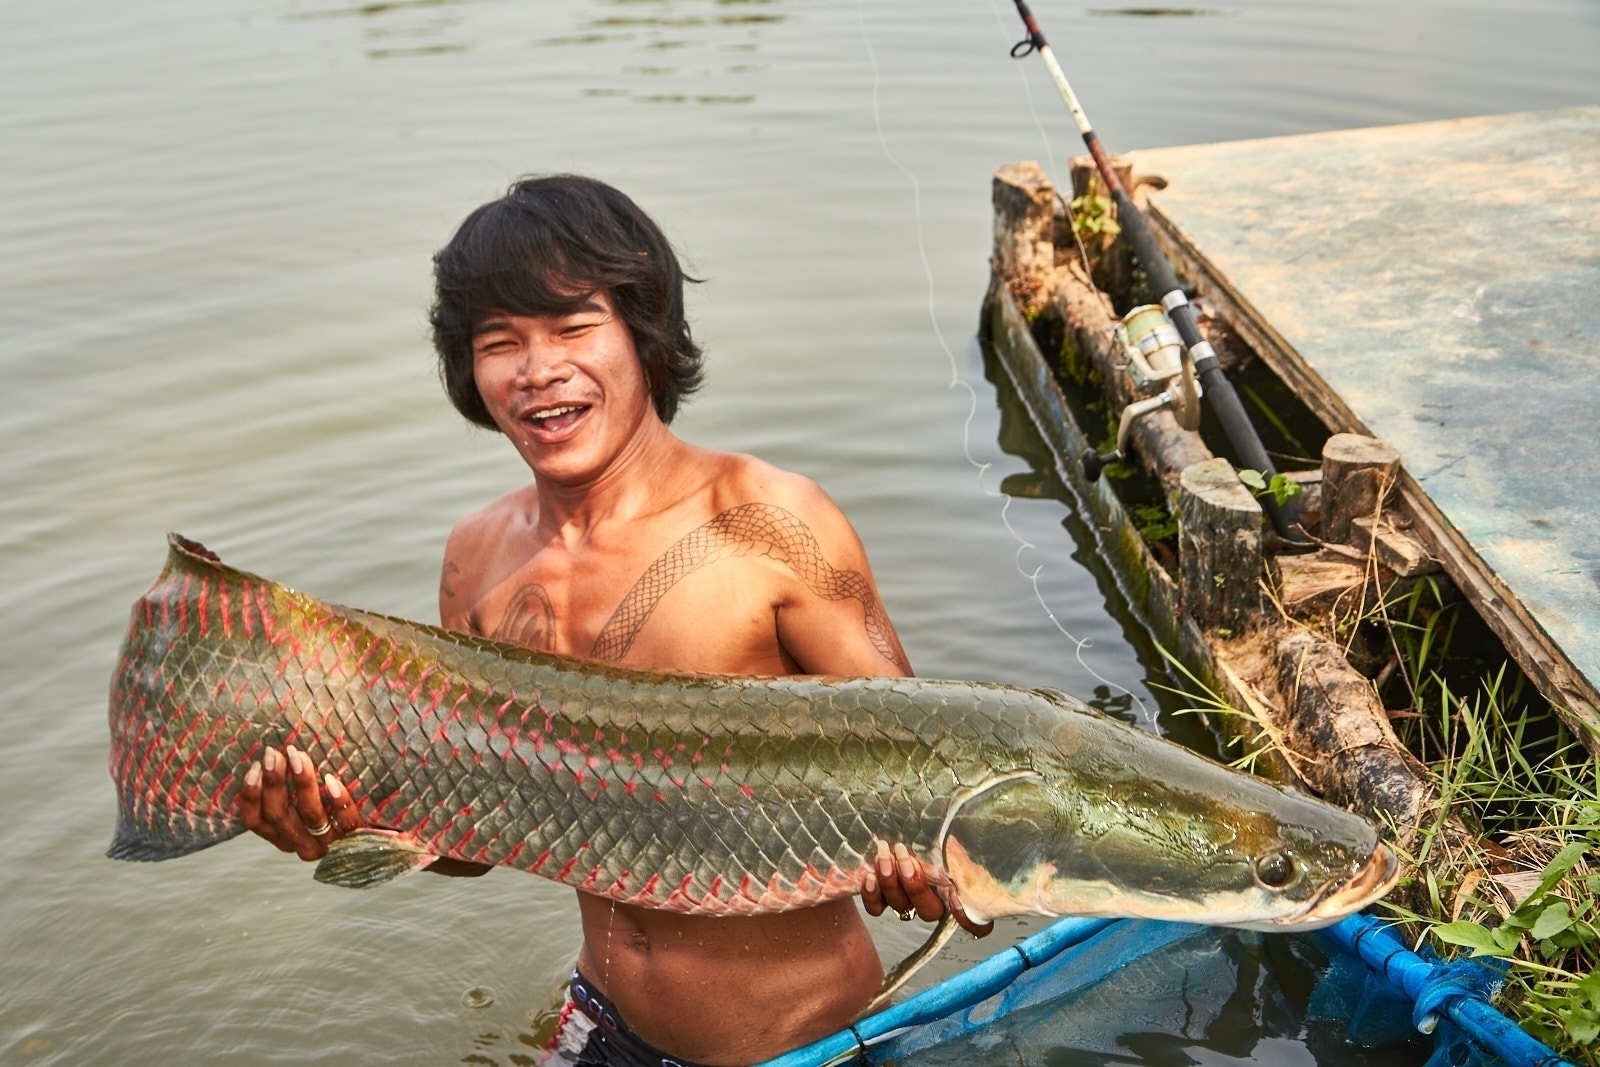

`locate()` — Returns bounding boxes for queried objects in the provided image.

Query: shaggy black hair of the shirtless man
[429,174,702,430]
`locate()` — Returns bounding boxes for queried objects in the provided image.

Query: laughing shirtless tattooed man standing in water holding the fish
[240,176,987,1065]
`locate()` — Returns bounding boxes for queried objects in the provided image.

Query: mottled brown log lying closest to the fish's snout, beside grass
[1274,630,1437,846]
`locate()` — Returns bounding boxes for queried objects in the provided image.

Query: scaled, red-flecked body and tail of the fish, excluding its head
[110,539,982,913]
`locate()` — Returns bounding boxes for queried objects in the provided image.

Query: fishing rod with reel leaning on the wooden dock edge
[1011,0,1307,544]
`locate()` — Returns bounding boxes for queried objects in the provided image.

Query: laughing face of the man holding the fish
[472,291,656,486]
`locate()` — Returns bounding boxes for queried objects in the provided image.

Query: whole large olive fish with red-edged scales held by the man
[109,536,1397,929]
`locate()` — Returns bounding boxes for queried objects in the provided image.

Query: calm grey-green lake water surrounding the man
[0,0,1600,1064]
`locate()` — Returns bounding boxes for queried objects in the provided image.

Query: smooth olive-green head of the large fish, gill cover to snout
[942,731,1398,931]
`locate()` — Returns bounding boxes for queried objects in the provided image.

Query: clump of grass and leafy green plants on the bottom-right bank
[1384,681,1600,1067]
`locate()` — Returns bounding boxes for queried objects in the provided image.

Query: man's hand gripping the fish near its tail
[238,745,363,859]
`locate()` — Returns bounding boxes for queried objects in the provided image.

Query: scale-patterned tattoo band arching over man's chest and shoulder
[590,504,907,670]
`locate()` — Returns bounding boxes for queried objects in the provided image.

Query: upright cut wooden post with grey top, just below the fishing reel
[1178,459,1261,633]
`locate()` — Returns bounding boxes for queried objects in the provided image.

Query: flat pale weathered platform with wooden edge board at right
[1134,107,1600,752]
